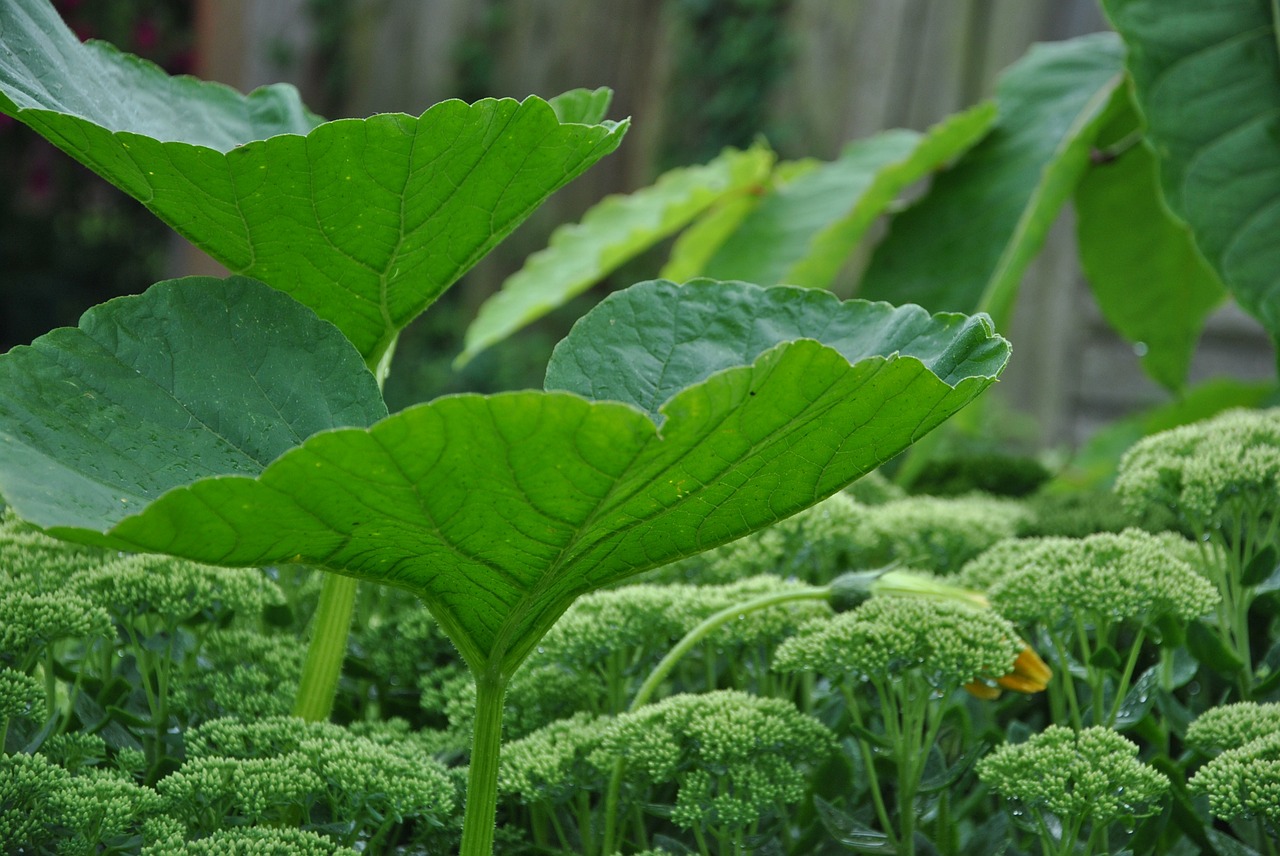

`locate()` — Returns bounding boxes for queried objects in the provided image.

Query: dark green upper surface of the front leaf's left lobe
[0,276,387,527]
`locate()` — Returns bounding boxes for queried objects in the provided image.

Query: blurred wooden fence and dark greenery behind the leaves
[0,0,1275,452]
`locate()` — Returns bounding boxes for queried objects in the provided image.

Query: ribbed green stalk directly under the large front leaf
[460,667,507,856]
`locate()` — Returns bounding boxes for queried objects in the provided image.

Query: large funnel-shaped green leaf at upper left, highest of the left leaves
[0,0,626,363]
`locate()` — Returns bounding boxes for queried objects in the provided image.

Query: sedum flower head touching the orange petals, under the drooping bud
[774,596,1025,690]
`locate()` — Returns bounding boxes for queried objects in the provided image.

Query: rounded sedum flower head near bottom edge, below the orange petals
[978,725,1169,853]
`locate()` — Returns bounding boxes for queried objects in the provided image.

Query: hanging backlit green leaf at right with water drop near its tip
[1075,87,1226,392]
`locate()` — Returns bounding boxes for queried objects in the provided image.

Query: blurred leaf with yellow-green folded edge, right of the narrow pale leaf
[703,104,996,288]
